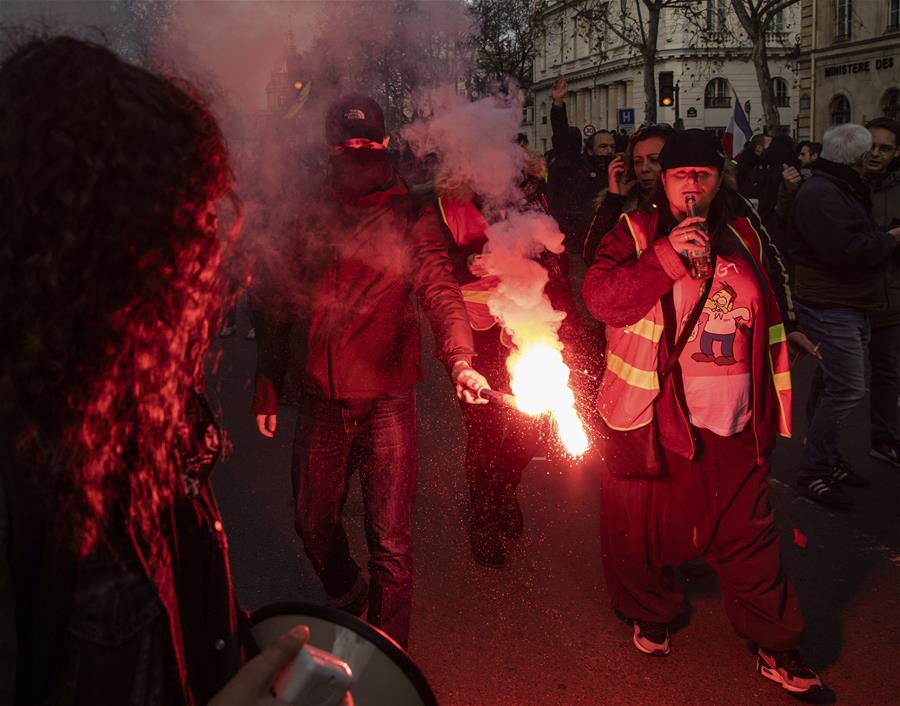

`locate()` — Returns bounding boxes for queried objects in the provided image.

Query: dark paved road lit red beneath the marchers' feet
[210,296,900,706]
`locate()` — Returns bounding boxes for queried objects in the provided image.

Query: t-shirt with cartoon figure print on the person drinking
[674,257,760,436]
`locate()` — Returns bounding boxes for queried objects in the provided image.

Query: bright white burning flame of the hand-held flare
[507,342,588,458]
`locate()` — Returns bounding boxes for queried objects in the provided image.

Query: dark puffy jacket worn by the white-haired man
[786,157,897,310]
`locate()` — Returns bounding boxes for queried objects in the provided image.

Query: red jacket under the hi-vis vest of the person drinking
[582,208,794,461]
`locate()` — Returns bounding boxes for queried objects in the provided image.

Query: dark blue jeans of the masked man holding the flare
[292,388,419,646]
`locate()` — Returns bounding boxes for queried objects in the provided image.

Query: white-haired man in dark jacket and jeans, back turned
[787,124,900,509]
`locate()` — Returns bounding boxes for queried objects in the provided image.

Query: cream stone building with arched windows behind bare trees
[523,0,800,150]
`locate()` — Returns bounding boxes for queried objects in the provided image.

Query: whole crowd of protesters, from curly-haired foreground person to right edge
[0,37,900,706]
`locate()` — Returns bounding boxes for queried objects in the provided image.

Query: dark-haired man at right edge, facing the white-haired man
[865,118,900,466]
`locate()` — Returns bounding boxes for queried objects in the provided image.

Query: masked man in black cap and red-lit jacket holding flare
[253,95,489,646]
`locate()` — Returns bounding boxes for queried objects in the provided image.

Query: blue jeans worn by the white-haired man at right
[796,302,869,482]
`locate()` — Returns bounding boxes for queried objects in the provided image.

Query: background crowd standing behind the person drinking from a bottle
[547,77,900,509]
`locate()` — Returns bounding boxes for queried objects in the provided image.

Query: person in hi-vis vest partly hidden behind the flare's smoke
[435,156,598,568]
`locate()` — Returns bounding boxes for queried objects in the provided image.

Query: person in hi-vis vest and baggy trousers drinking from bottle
[583,130,822,693]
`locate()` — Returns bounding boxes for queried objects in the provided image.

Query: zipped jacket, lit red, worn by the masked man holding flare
[253,175,474,414]
